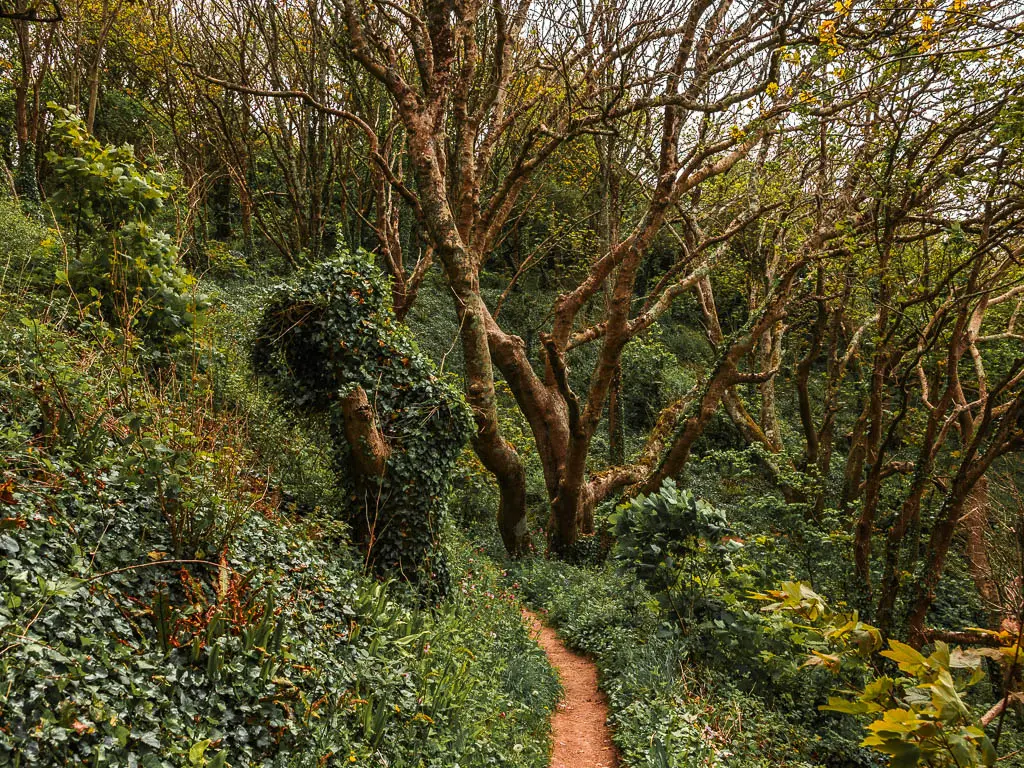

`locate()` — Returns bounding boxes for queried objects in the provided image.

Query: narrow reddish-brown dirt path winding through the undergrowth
[523,610,618,768]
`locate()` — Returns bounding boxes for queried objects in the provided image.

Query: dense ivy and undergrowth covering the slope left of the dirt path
[0,268,558,768]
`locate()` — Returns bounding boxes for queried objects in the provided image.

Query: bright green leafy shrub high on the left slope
[46,104,202,343]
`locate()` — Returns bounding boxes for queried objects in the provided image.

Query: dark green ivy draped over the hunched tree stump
[249,252,471,592]
